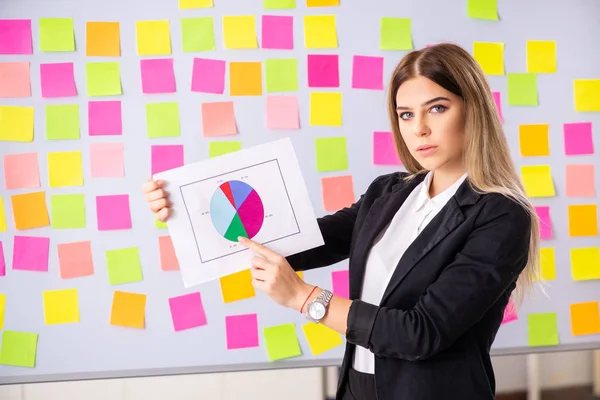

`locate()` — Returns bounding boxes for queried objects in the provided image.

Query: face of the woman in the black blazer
[396,77,465,171]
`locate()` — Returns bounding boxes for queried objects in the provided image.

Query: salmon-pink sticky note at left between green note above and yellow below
[56,240,94,279]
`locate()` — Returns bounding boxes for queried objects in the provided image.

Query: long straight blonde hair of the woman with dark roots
[388,43,540,305]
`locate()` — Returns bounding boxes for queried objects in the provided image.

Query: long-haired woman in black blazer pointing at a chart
[143,44,538,400]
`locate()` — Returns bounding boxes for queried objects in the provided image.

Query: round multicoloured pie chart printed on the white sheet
[210,180,265,242]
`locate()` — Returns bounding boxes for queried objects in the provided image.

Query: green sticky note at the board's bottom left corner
[0,331,38,368]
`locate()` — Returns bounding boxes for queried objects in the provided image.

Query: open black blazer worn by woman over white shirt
[287,173,531,400]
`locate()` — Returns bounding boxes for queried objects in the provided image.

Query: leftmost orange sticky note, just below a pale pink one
[11,192,50,231]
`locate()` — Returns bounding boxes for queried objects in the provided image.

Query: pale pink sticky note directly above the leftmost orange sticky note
[4,153,40,190]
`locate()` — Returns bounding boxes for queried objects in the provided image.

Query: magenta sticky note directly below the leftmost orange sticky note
[12,236,50,272]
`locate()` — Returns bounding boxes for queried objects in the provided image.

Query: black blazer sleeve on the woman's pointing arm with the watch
[346,198,531,360]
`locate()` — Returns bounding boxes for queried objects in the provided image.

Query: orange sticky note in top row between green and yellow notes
[85,21,121,57]
